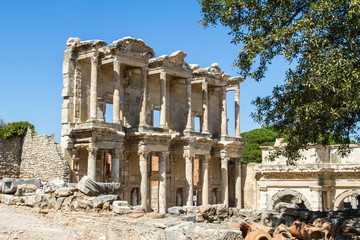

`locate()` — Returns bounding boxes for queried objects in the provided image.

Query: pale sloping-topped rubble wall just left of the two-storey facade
[20,132,70,181]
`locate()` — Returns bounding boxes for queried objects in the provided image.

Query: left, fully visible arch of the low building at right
[267,189,310,211]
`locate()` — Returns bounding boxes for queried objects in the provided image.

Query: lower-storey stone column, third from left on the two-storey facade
[139,149,148,211]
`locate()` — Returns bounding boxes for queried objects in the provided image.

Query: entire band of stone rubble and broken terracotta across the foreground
[0,176,360,240]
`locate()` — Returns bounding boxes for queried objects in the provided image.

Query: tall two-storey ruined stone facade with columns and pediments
[61,37,244,212]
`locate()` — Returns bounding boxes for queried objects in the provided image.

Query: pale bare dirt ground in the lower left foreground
[0,204,194,240]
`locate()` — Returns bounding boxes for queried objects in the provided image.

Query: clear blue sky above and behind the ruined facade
[0,0,287,141]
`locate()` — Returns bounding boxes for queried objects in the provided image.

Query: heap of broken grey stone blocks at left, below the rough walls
[0,176,126,211]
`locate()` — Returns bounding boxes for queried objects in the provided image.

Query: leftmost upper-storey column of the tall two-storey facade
[90,51,99,120]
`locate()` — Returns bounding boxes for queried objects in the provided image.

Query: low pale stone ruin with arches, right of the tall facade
[243,139,360,211]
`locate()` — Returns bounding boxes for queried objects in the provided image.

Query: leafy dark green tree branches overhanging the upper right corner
[200,0,360,159]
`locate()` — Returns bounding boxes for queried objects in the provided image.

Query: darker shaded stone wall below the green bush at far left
[0,137,23,179]
